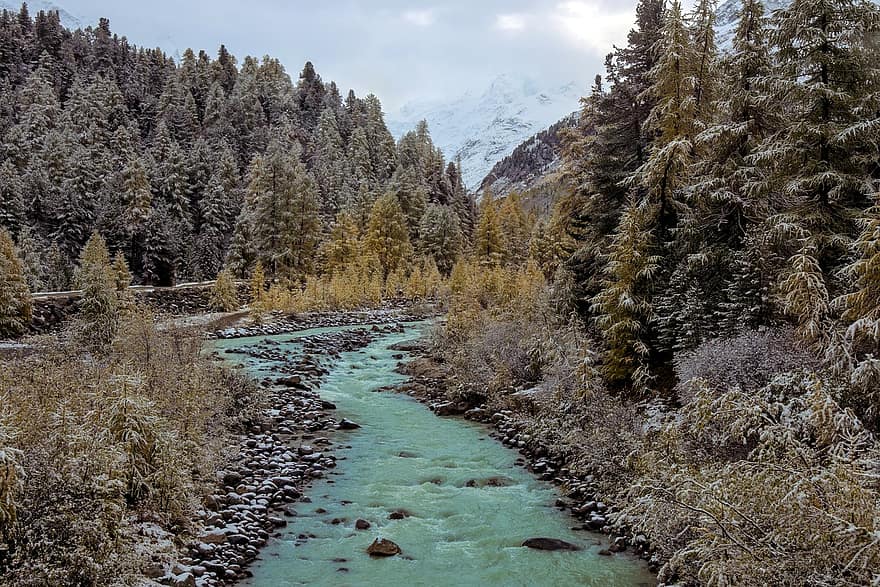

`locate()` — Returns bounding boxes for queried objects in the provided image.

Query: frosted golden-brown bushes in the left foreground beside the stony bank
[0,310,260,585]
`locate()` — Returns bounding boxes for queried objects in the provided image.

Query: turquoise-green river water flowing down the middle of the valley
[218,328,654,587]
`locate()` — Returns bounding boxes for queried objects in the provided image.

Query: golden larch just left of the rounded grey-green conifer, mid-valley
[364,193,412,279]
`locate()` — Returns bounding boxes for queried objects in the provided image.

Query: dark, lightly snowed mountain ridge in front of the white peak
[479,113,578,197]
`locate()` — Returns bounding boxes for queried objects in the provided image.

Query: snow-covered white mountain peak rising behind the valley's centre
[388,74,585,189]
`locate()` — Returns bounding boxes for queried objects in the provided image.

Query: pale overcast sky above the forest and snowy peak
[62,0,664,111]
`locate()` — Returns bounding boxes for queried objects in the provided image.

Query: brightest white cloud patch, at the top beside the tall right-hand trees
[552,0,635,55]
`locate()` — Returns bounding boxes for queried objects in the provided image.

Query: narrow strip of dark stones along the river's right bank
[386,341,662,572]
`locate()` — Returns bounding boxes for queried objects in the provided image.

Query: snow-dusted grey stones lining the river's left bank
[145,310,415,587]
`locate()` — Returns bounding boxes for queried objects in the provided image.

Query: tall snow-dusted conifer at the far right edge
[749,0,880,340]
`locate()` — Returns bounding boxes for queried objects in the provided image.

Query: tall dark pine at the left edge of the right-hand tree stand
[560,0,664,312]
